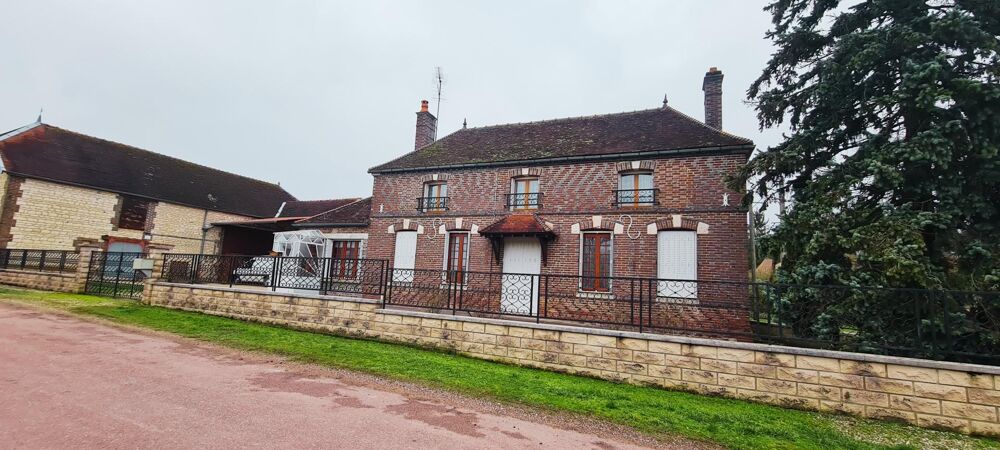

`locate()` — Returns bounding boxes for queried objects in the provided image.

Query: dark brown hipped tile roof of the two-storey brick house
[369,106,753,173]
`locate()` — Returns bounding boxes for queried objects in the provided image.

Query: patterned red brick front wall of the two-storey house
[366,152,748,333]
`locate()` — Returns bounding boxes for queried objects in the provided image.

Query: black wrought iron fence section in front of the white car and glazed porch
[161,254,386,296]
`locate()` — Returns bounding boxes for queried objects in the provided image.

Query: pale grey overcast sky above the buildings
[0,0,780,199]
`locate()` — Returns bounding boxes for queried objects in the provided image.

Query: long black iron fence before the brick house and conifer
[384,269,1000,364]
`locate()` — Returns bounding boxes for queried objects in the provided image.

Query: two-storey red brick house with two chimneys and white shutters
[368,68,754,330]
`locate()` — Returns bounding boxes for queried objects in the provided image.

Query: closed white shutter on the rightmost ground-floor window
[656,231,698,298]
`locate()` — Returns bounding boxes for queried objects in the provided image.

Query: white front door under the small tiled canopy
[500,237,542,315]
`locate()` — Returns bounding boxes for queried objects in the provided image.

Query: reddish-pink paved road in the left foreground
[0,302,687,449]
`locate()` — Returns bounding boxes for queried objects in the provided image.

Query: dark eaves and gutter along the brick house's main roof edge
[368,142,756,175]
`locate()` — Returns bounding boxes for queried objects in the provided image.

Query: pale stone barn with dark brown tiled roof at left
[0,122,295,253]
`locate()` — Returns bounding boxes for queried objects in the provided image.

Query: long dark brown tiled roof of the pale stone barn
[0,124,295,217]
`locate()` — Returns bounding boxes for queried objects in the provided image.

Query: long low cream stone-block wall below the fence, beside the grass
[144,283,1000,436]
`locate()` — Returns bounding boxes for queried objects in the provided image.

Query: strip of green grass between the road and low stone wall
[0,288,1000,449]
